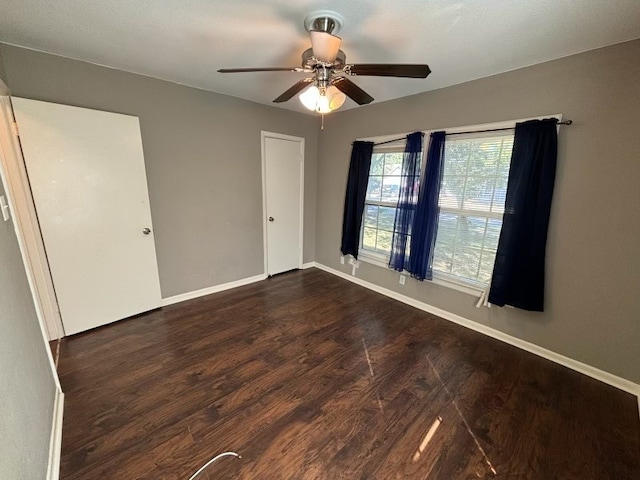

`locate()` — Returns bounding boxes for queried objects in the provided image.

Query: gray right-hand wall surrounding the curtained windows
[316,41,640,383]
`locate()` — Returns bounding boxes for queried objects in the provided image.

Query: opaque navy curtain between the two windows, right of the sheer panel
[407,132,446,280]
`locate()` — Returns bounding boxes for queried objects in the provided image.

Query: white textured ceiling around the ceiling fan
[0,0,640,111]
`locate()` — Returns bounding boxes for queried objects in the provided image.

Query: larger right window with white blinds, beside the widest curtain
[433,132,513,286]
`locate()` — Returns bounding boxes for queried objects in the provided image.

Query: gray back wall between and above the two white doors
[0,44,318,297]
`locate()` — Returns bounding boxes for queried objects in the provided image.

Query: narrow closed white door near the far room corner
[262,132,304,275]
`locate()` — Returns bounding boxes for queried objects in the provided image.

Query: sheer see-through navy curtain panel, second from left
[389,132,424,272]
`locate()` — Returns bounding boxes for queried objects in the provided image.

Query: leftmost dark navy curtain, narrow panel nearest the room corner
[340,141,373,258]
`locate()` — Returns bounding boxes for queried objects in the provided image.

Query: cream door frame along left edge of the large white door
[0,91,65,340]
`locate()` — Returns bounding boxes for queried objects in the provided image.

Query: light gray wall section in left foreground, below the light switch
[0,165,56,480]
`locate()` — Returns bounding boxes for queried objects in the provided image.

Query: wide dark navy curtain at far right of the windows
[489,118,558,312]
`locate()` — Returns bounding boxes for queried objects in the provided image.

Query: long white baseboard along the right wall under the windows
[314,262,640,400]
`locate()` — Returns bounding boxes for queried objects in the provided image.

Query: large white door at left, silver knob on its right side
[12,97,161,335]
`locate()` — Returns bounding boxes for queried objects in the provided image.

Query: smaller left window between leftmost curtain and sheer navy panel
[361,146,416,258]
